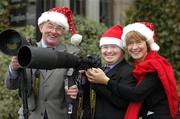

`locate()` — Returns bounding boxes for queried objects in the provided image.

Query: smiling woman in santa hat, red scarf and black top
[86,22,178,119]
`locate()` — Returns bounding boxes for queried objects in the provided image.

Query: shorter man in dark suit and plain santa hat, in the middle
[82,25,136,119]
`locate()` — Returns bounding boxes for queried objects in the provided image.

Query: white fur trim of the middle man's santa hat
[99,37,123,49]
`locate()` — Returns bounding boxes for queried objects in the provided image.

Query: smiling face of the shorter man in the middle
[101,44,124,64]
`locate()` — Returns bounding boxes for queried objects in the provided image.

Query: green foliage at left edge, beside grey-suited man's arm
[0,54,19,119]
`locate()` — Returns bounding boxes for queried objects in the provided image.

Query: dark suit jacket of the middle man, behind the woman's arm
[94,59,136,119]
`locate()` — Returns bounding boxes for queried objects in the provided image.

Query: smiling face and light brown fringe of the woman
[126,31,149,62]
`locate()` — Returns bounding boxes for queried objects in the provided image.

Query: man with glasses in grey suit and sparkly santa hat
[6,7,82,119]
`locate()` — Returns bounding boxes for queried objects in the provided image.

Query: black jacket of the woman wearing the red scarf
[108,72,172,119]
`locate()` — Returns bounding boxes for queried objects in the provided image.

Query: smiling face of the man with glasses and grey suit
[39,21,65,47]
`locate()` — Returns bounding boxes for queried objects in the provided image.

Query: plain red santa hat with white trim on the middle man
[99,25,123,49]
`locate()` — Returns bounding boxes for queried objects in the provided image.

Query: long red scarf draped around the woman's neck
[124,51,178,119]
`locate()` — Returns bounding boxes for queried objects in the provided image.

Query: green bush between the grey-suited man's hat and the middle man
[62,16,107,55]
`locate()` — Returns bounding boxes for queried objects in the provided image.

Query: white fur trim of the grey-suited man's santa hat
[38,11,69,31]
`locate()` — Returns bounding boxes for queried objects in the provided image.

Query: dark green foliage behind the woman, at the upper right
[126,0,180,79]
